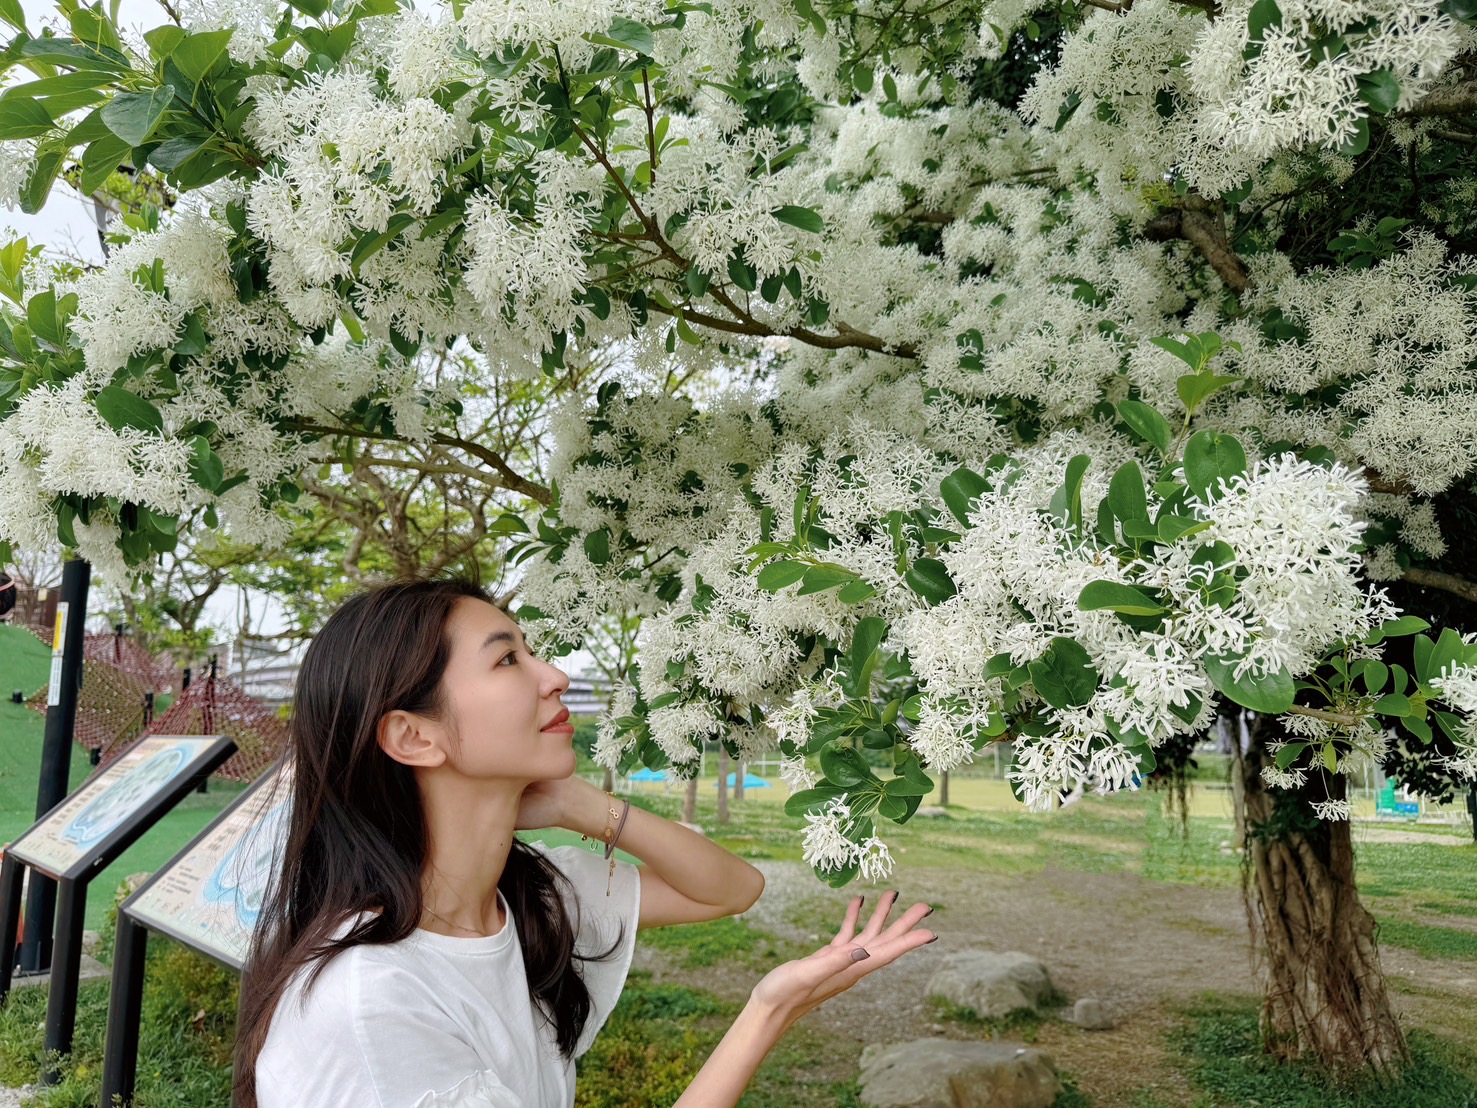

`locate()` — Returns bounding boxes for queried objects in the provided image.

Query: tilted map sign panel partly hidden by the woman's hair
[121,762,292,969]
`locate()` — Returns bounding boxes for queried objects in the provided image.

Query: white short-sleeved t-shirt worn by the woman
[257,844,641,1108]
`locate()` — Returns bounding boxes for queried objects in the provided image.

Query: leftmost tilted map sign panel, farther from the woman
[6,734,235,879]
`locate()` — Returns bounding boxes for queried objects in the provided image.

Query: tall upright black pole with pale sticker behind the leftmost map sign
[21,558,92,974]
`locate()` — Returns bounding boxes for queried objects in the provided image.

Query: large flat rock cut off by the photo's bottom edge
[861,1039,1062,1108]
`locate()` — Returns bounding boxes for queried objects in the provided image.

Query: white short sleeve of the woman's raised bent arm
[530,842,641,1058]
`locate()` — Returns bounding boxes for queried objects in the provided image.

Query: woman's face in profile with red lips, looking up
[442,597,575,782]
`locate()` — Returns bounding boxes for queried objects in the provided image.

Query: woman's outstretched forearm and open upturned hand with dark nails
[672,892,935,1108]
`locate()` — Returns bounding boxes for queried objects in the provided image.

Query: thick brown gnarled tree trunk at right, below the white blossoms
[1244,717,1408,1074]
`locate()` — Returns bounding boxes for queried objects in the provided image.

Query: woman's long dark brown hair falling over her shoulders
[235,578,598,1108]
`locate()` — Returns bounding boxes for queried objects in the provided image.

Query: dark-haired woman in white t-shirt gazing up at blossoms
[235,581,932,1108]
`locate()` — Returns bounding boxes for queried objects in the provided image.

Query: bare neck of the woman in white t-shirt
[421,774,523,938]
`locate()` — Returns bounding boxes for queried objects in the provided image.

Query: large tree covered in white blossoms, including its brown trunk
[0,0,1477,1070]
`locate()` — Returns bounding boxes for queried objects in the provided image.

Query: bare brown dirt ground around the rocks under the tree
[641,861,1477,1108]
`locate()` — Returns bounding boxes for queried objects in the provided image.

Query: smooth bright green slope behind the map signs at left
[0,625,242,931]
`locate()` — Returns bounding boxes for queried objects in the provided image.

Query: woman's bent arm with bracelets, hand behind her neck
[518,777,764,928]
